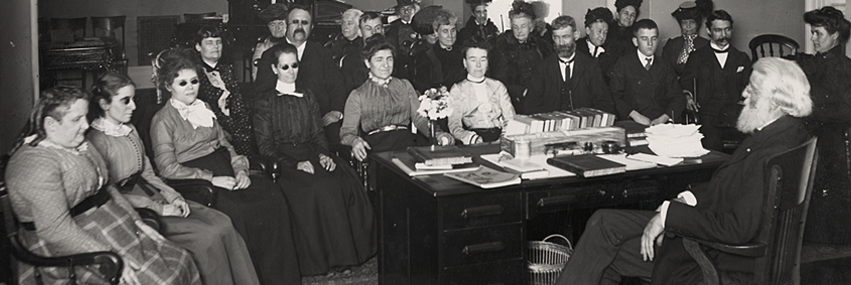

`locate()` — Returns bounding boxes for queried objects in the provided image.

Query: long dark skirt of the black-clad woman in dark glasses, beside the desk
[278,145,377,275]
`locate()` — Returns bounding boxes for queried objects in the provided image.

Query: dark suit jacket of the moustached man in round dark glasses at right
[680,45,751,116]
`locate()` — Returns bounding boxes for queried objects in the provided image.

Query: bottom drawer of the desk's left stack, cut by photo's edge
[440,259,527,285]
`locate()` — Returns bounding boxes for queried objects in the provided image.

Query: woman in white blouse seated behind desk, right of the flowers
[448,35,514,144]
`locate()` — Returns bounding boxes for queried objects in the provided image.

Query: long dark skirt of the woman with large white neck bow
[182,151,301,284]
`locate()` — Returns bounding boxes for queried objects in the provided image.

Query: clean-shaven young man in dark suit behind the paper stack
[609,19,686,123]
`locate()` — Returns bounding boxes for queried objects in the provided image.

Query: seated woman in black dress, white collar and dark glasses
[254,43,377,275]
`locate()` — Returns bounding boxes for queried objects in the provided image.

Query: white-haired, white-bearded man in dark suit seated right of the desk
[556,58,812,284]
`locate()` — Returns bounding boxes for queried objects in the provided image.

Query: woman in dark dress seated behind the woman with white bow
[195,26,254,157]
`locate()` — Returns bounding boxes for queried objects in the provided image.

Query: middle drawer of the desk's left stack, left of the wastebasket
[440,224,525,268]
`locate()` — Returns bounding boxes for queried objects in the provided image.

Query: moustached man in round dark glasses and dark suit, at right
[680,10,751,150]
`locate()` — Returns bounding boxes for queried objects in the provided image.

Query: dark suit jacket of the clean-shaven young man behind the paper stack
[609,51,686,120]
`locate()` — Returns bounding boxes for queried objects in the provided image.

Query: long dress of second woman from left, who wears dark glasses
[86,119,260,285]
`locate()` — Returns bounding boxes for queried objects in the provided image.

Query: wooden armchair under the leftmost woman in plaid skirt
[0,155,123,284]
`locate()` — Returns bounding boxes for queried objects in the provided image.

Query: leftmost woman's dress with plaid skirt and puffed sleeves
[6,141,201,284]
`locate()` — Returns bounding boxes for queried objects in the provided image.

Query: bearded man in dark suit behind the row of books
[526,16,615,114]
